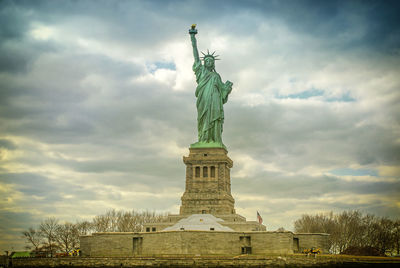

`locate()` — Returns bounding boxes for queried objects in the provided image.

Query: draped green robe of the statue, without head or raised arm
[193,61,230,144]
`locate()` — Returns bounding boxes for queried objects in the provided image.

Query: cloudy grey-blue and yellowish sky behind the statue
[0,0,400,251]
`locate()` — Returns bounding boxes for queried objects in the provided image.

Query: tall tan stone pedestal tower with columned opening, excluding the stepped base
[180,148,235,215]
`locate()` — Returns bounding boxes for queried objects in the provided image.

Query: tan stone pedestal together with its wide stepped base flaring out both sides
[144,147,266,232]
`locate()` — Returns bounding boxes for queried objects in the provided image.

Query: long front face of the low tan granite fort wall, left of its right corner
[81,231,293,257]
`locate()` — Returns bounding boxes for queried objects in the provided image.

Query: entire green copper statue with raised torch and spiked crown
[189,24,232,149]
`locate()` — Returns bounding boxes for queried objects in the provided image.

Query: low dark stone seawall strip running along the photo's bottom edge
[12,254,400,268]
